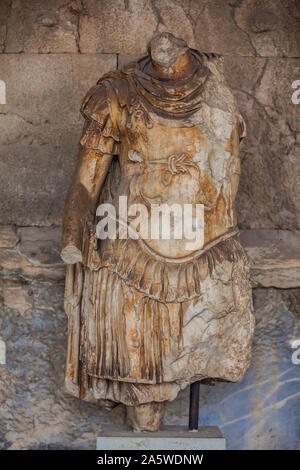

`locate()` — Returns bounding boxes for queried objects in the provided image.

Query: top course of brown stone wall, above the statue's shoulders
[0,0,300,57]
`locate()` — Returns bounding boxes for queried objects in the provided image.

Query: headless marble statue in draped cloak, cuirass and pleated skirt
[61,33,254,431]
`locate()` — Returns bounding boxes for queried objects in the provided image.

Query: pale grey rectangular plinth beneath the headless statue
[97,425,226,450]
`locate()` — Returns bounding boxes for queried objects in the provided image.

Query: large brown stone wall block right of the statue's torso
[225,57,300,229]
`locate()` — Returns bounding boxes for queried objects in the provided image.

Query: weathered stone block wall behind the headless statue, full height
[0,0,300,449]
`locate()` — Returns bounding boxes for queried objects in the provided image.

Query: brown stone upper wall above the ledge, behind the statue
[0,0,300,229]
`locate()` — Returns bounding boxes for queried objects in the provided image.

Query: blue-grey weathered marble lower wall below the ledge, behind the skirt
[0,280,300,449]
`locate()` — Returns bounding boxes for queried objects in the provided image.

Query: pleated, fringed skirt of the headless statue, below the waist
[65,235,254,405]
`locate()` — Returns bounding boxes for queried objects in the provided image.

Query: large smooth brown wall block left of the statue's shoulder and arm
[0,54,116,225]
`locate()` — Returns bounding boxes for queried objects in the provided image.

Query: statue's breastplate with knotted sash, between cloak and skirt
[111,105,239,258]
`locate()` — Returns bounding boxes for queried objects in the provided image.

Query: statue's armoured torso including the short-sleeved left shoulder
[81,52,245,260]
